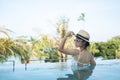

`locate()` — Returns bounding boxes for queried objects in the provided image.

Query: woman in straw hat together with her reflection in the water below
[58,30,96,80]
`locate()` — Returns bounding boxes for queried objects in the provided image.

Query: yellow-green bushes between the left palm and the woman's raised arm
[32,34,59,62]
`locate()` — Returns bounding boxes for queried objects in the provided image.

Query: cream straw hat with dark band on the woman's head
[76,30,90,42]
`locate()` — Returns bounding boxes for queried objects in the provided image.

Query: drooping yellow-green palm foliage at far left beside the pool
[0,27,31,63]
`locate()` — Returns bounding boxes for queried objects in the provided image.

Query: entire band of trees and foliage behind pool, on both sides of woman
[0,19,120,63]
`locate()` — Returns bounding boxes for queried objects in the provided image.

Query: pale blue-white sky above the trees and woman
[0,0,120,41]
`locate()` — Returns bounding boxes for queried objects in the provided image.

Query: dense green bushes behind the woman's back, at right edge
[89,36,120,59]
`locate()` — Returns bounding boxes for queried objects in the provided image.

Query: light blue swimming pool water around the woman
[0,60,120,80]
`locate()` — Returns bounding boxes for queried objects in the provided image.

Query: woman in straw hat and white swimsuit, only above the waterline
[58,30,96,66]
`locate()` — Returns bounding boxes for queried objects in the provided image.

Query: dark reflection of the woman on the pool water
[57,65,95,80]
